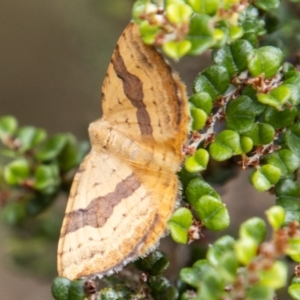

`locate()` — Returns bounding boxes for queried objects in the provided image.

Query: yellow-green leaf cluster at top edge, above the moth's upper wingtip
[133,0,268,59]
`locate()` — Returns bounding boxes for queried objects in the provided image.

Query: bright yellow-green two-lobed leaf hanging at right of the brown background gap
[251,164,281,192]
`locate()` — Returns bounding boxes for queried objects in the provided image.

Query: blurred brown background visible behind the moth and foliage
[0,0,298,300]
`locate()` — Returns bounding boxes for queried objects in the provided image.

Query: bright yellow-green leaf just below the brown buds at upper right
[257,84,291,110]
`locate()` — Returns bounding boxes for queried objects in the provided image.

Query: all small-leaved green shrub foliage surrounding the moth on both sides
[0,0,300,300]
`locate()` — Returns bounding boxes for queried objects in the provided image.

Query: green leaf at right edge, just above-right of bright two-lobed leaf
[267,149,300,176]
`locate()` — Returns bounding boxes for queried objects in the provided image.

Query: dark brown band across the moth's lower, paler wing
[60,174,140,238]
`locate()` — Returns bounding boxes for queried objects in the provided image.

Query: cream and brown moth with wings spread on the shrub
[57,23,189,280]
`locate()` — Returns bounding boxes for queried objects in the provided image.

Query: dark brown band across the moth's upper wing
[112,45,153,135]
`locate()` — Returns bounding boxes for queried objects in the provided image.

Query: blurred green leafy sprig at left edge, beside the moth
[0,116,86,225]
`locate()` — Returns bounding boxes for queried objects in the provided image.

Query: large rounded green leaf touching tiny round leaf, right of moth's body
[209,130,242,161]
